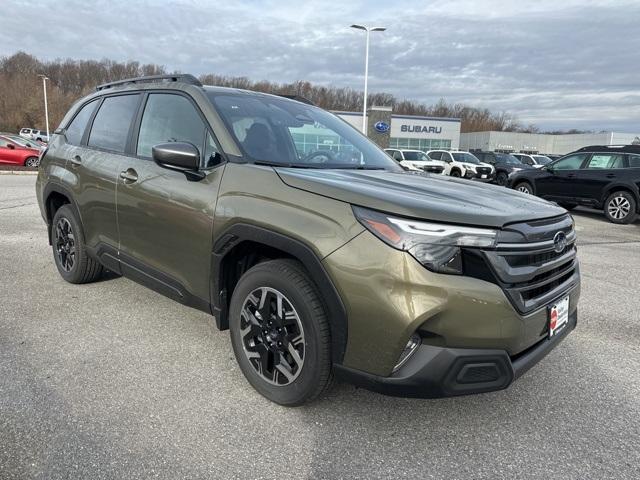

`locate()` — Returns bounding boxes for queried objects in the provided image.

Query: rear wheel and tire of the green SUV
[51,205,103,283]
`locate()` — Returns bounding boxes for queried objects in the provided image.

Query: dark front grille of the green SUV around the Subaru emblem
[466,217,579,314]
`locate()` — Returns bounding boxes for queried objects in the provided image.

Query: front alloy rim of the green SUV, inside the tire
[240,287,305,386]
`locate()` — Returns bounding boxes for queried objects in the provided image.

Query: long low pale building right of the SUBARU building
[460,132,640,155]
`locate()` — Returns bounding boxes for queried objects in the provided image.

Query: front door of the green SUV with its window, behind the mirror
[117,93,224,304]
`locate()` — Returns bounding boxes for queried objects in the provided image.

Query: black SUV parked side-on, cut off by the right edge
[510,145,640,223]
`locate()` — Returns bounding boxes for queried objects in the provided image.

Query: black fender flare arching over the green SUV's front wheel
[210,223,348,363]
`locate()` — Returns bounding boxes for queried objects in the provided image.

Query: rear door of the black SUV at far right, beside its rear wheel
[574,152,625,205]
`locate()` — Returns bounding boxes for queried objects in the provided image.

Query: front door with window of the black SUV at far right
[536,153,590,202]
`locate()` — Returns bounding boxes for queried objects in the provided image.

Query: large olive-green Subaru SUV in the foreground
[36,75,580,405]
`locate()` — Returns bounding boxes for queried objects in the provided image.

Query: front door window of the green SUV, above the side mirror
[137,93,206,157]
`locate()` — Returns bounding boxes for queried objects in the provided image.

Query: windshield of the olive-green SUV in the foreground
[207,92,404,172]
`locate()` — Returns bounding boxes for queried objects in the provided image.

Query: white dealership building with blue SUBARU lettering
[333,107,460,151]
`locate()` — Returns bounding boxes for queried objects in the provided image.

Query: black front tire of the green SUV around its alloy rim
[229,260,332,406]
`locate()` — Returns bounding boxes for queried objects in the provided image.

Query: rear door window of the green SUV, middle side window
[88,95,140,153]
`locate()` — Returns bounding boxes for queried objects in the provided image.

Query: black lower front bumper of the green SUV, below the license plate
[334,310,578,398]
